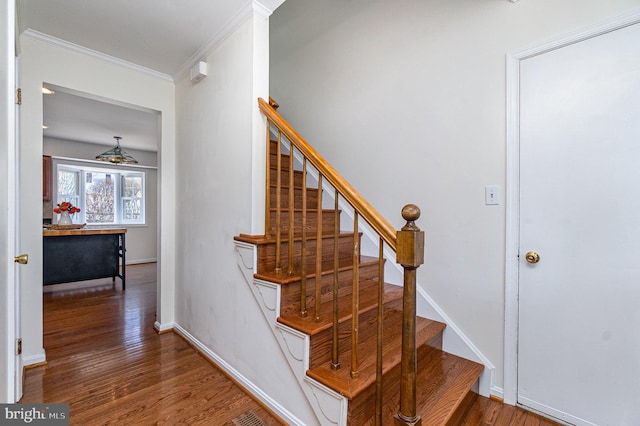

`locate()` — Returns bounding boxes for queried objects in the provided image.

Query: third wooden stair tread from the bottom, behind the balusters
[278,282,402,336]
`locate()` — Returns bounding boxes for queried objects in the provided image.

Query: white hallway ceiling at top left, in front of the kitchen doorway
[18,0,250,77]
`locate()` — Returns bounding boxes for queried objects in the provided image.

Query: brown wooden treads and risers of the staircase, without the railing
[242,136,484,426]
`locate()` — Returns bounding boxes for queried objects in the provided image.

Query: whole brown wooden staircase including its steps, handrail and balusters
[236,100,483,425]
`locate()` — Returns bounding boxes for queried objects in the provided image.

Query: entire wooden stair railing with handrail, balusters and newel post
[258,98,424,426]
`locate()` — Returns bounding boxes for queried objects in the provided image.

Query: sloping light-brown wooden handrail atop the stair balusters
[258,98,397,251]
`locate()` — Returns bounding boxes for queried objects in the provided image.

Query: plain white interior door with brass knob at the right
[518,24,640,426]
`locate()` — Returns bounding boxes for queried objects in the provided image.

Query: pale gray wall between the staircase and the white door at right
[270,0,639,394]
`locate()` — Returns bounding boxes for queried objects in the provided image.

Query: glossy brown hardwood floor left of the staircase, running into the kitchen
[20,263,282,426]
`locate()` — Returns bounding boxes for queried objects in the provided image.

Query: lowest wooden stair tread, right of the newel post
[416,348,484,426]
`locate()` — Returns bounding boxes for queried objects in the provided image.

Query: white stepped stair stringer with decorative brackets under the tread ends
[234,241,349,426]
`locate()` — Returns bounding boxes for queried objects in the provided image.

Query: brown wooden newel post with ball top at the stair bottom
[395,204,424,426]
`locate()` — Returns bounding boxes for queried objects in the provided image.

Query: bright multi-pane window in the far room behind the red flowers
[57,165,145,225]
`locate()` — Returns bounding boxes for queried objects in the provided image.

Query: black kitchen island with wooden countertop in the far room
[42,228,127,290]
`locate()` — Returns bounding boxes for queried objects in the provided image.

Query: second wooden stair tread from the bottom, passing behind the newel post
[307,317,445,400]
